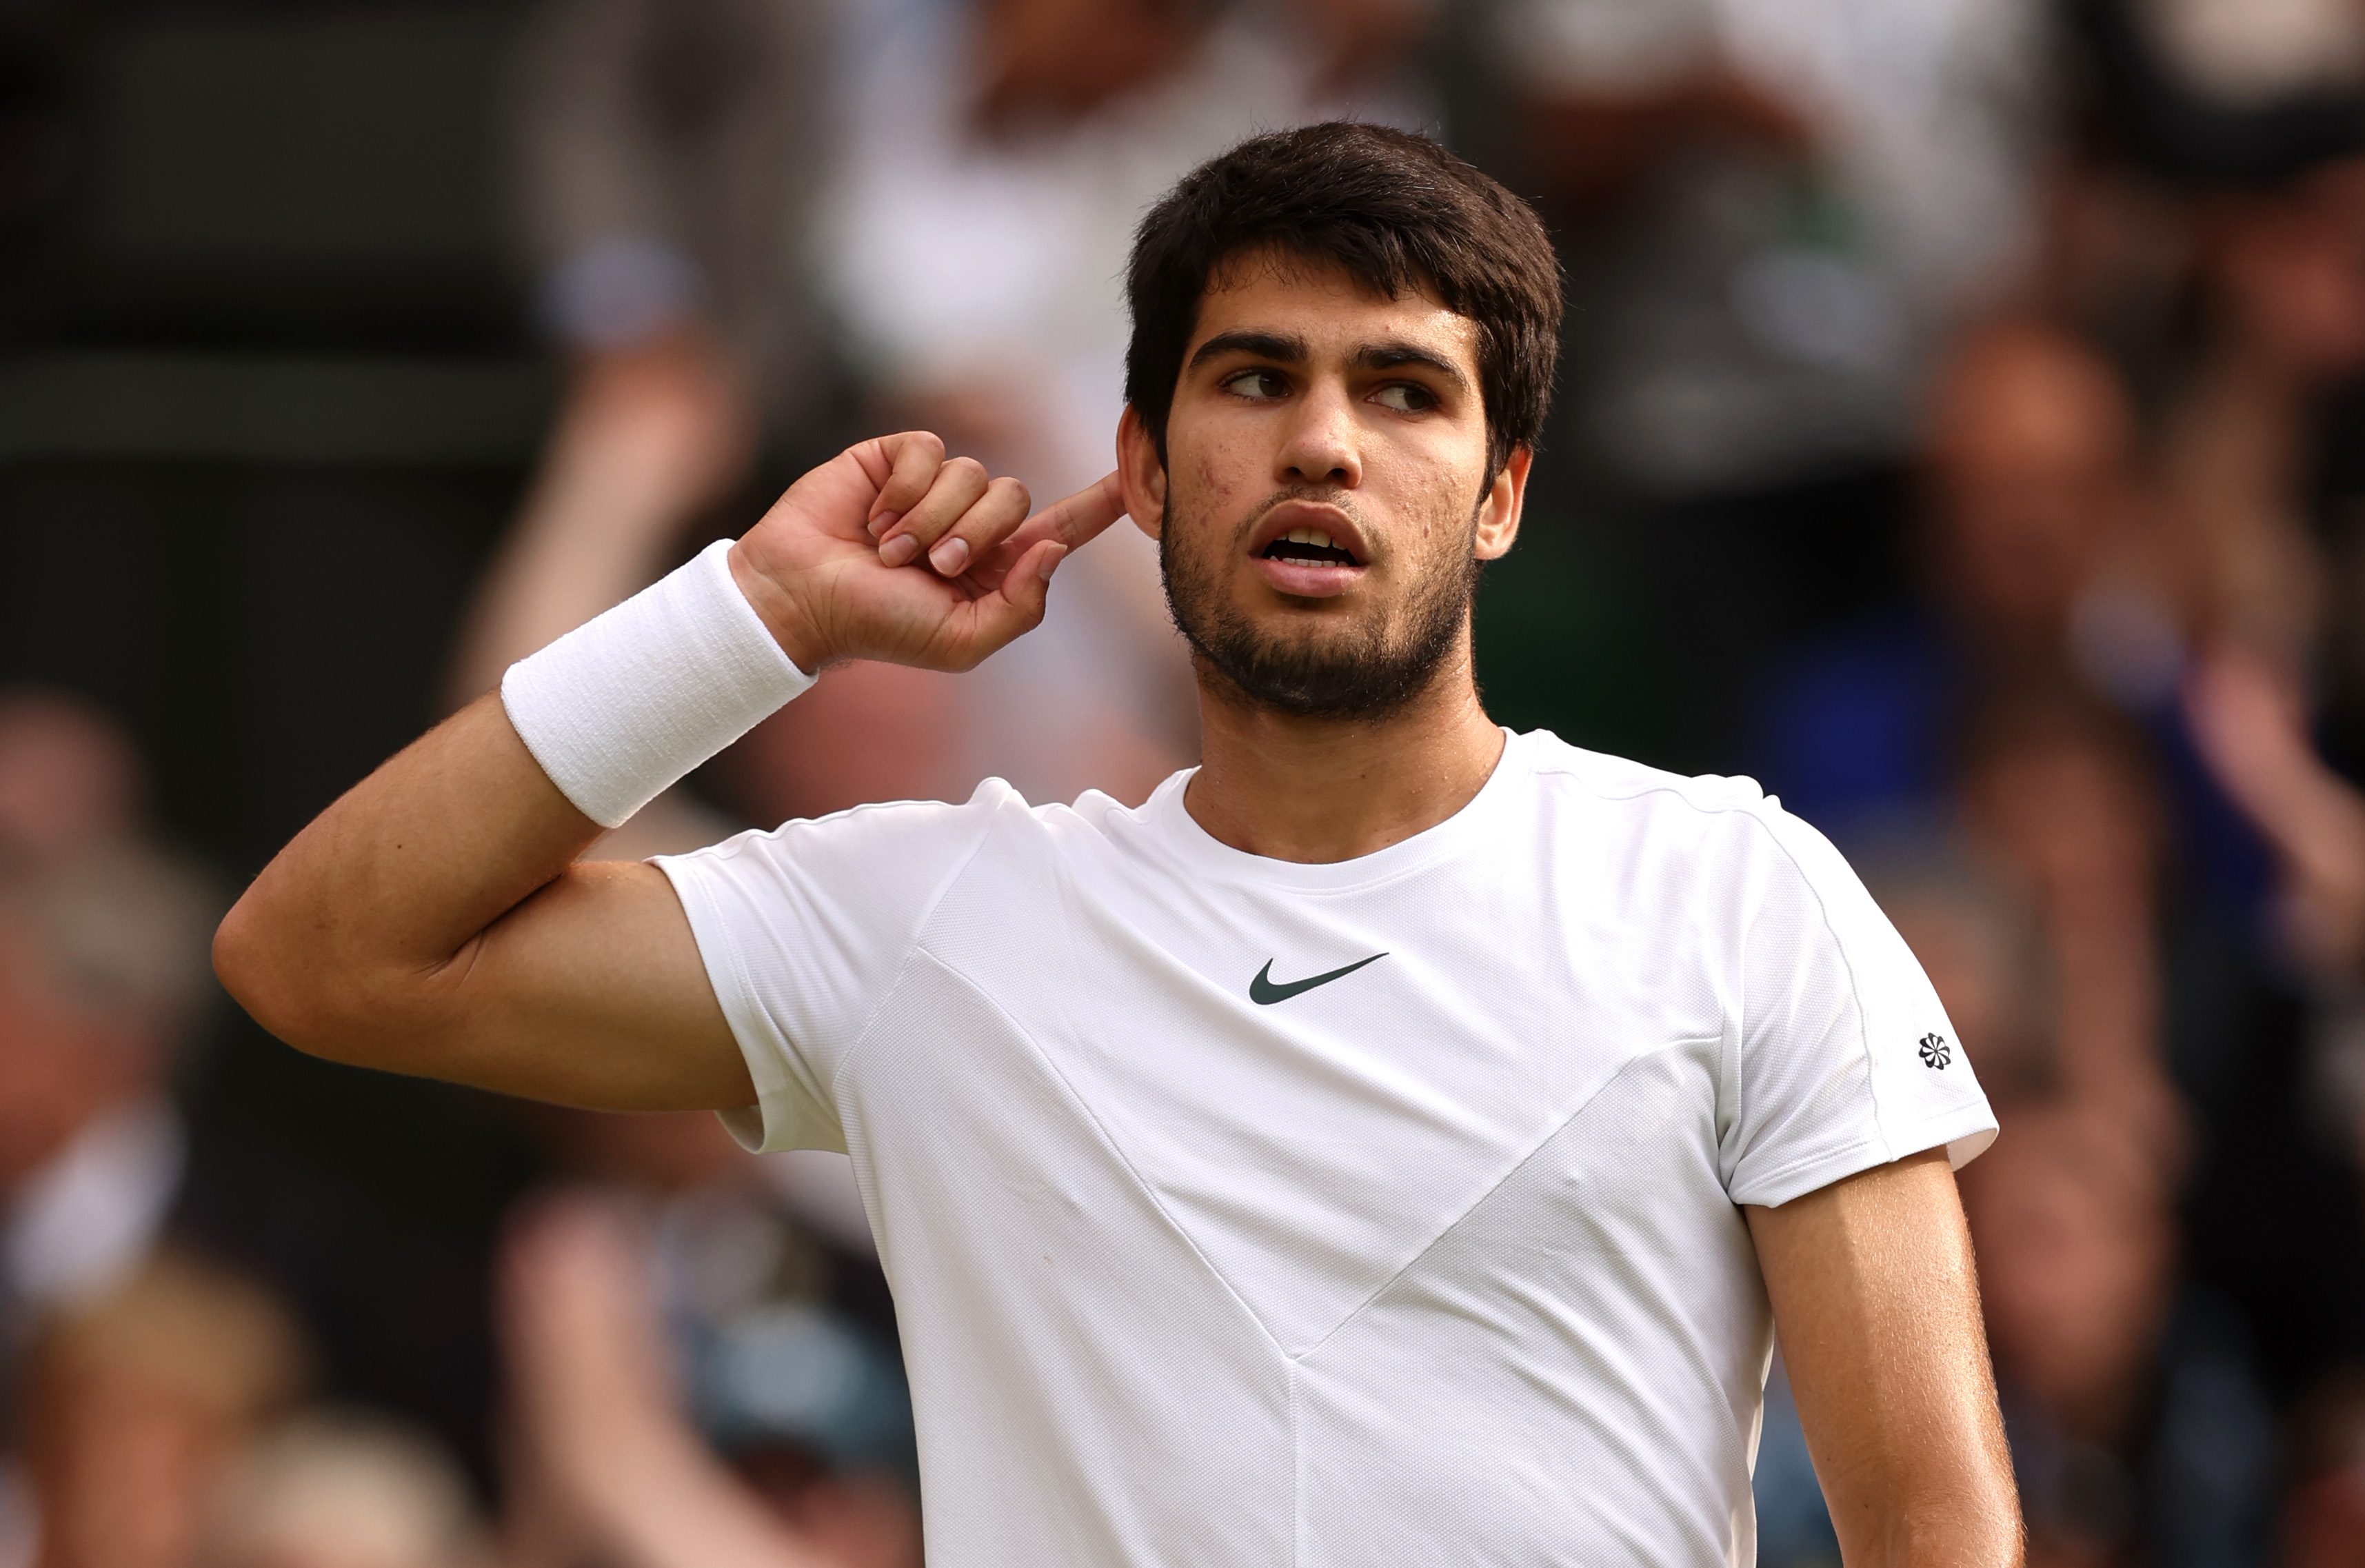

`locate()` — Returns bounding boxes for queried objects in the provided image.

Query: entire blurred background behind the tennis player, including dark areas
[0,0,2365,1568]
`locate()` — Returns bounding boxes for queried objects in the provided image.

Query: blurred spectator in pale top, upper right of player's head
[1495,0,2046,494]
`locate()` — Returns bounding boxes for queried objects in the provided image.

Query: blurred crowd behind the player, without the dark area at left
[14,0,2365,1568]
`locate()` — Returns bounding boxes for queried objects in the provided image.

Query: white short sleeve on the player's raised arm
[655,778,1024,1154]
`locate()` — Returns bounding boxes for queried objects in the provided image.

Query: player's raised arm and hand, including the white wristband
[215,435,1118,1112]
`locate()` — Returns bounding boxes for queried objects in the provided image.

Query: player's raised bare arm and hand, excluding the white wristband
[213,435,1121,1109]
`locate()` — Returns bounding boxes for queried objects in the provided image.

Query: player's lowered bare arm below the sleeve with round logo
[1745,1149,2022,1568]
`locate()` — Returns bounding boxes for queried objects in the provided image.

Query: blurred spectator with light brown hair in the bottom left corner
[21,1251,308,1568]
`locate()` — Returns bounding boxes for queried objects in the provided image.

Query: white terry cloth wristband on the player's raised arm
[501,539,814,827]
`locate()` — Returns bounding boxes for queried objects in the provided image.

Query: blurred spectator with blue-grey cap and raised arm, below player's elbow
[501,1192,920,1568]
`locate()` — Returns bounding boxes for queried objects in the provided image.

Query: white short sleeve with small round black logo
[1722,802,1996,1206]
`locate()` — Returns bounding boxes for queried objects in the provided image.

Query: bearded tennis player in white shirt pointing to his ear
[218,125,2020,1568]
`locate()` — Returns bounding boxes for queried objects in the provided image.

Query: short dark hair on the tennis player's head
[1126,121,1561,473]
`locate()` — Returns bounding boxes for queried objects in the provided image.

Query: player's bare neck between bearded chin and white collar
[1182,634,1502,863]
